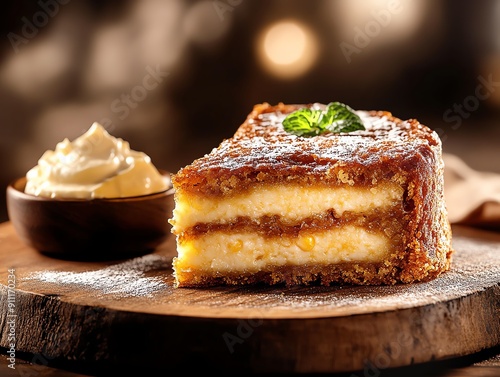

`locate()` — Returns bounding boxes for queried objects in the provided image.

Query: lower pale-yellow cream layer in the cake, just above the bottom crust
[174,225,391,281]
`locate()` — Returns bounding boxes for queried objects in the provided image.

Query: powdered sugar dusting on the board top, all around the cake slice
[17,226,500,318]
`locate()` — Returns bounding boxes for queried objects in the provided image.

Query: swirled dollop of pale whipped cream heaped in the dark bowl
[24,122,169,199]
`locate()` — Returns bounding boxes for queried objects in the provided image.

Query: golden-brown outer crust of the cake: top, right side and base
[172,104,453,286]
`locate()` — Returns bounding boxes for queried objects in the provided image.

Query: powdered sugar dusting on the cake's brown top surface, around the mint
[181,104,441,179]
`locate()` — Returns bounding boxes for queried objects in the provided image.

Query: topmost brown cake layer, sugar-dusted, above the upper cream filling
[173,104,442,196]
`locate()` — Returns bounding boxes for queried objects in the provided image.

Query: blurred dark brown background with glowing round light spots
[0,0,500,221]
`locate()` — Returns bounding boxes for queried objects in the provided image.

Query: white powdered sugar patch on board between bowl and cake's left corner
[25,254,168,297]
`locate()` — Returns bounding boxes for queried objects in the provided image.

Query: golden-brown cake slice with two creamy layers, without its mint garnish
[170,103,452,287]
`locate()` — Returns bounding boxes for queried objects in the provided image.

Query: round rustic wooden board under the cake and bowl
[0,223,500,376]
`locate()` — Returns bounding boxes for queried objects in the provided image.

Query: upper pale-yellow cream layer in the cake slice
[171,182,404,233]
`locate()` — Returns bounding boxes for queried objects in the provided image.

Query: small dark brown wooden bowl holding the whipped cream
[7,171,174,260]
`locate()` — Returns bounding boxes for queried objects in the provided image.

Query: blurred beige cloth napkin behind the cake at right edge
[443,153,500,231]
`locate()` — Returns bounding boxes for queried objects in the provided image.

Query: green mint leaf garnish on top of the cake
[283,102,365,137]
